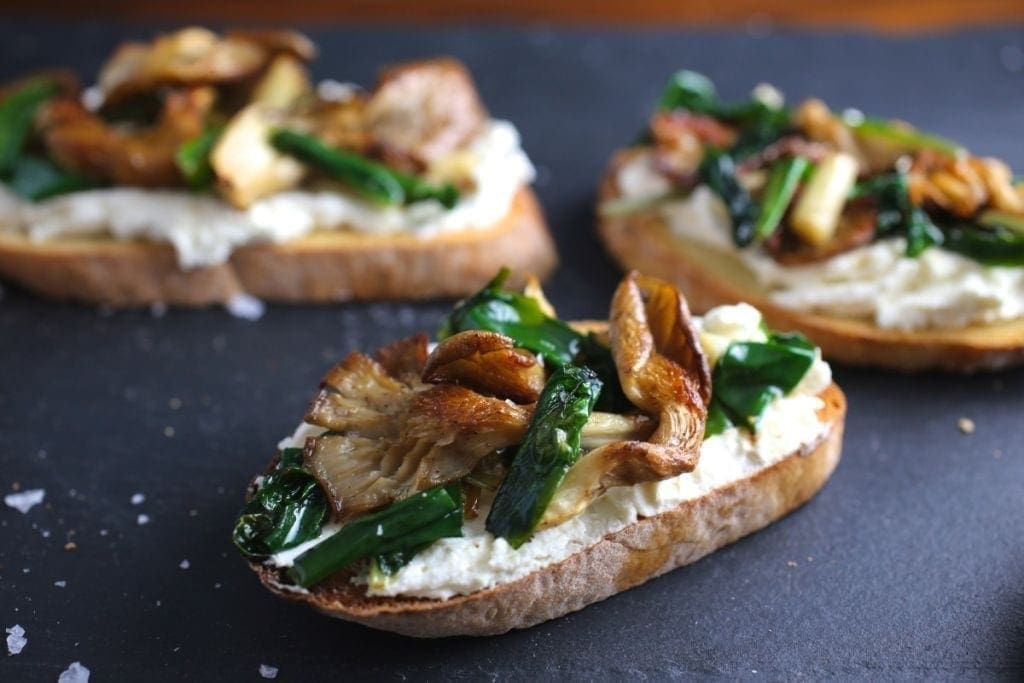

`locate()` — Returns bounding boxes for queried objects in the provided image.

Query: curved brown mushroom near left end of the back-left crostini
[40,87,215,187]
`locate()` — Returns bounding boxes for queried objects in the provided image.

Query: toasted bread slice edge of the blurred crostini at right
[598,150,1024,373]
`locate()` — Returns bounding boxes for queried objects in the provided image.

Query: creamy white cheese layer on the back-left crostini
[0,121,534,269]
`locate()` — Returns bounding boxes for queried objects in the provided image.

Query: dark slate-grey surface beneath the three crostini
[0,24,1024,681]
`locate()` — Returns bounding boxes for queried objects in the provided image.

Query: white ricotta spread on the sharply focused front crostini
[268,304,831,599]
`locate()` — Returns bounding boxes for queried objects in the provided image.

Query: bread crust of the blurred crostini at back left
[0,186,557,307]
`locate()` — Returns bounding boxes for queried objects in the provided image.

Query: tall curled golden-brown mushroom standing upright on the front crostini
[540,272,711,527]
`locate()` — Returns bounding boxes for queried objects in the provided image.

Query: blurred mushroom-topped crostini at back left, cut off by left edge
[0,28,556,306]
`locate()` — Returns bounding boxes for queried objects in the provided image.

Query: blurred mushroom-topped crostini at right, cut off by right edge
[598,71,1024,372]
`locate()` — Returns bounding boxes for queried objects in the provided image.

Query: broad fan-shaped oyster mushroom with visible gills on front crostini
[305,335,653,519]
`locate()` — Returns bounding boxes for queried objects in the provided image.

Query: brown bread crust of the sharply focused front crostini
[252,384,846,638]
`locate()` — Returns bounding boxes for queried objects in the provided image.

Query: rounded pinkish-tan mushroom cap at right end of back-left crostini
[366,57,487,171]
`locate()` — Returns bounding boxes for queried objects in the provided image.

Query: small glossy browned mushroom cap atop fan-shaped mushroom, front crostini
[423,330,544,403]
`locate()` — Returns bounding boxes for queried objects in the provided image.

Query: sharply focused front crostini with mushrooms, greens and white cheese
[233,273,846,637]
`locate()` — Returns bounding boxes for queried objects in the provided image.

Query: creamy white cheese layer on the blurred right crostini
[617,150,1024,330]
